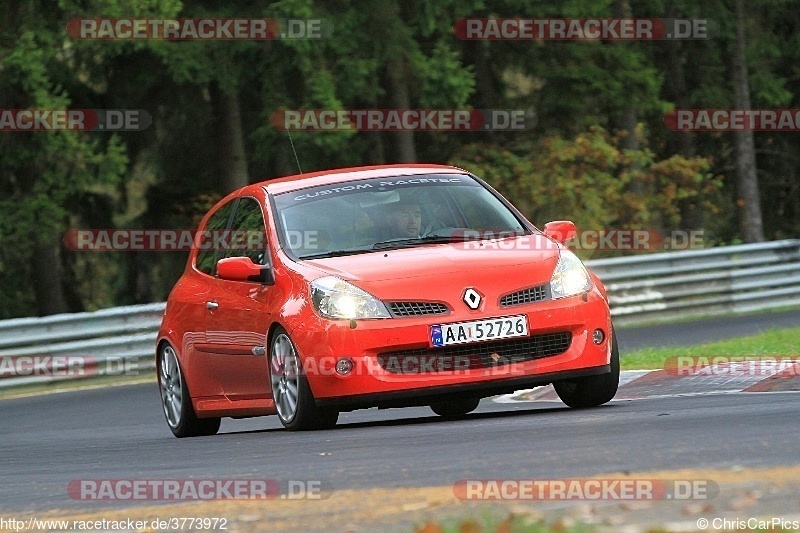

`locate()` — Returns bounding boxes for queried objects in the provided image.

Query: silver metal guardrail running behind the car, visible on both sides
[0,240,800,388]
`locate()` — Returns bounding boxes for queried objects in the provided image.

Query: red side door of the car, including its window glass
[206,196,271,401]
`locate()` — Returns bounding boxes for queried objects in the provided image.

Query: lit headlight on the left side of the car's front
[311,276,391,320]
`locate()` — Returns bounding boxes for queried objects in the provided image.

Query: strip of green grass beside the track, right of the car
[620,328,800,370]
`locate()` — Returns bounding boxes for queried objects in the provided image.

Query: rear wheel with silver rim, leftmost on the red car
[158,344,222,438]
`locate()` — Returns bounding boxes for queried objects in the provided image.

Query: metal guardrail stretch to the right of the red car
[586,240,800,325]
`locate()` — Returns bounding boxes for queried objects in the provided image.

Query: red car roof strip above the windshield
[254,164,467,194]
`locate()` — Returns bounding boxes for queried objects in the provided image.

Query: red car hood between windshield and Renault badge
[302,235,558,299]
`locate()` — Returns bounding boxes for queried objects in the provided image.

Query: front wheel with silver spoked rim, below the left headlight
[269,328,339,431]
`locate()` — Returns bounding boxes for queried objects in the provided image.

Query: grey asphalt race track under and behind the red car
[0,311,800,514]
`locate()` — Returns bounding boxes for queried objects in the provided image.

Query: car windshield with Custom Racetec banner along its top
[275,174,527,259]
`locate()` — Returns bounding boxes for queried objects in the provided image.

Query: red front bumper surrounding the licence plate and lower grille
[290,288,611,409]
